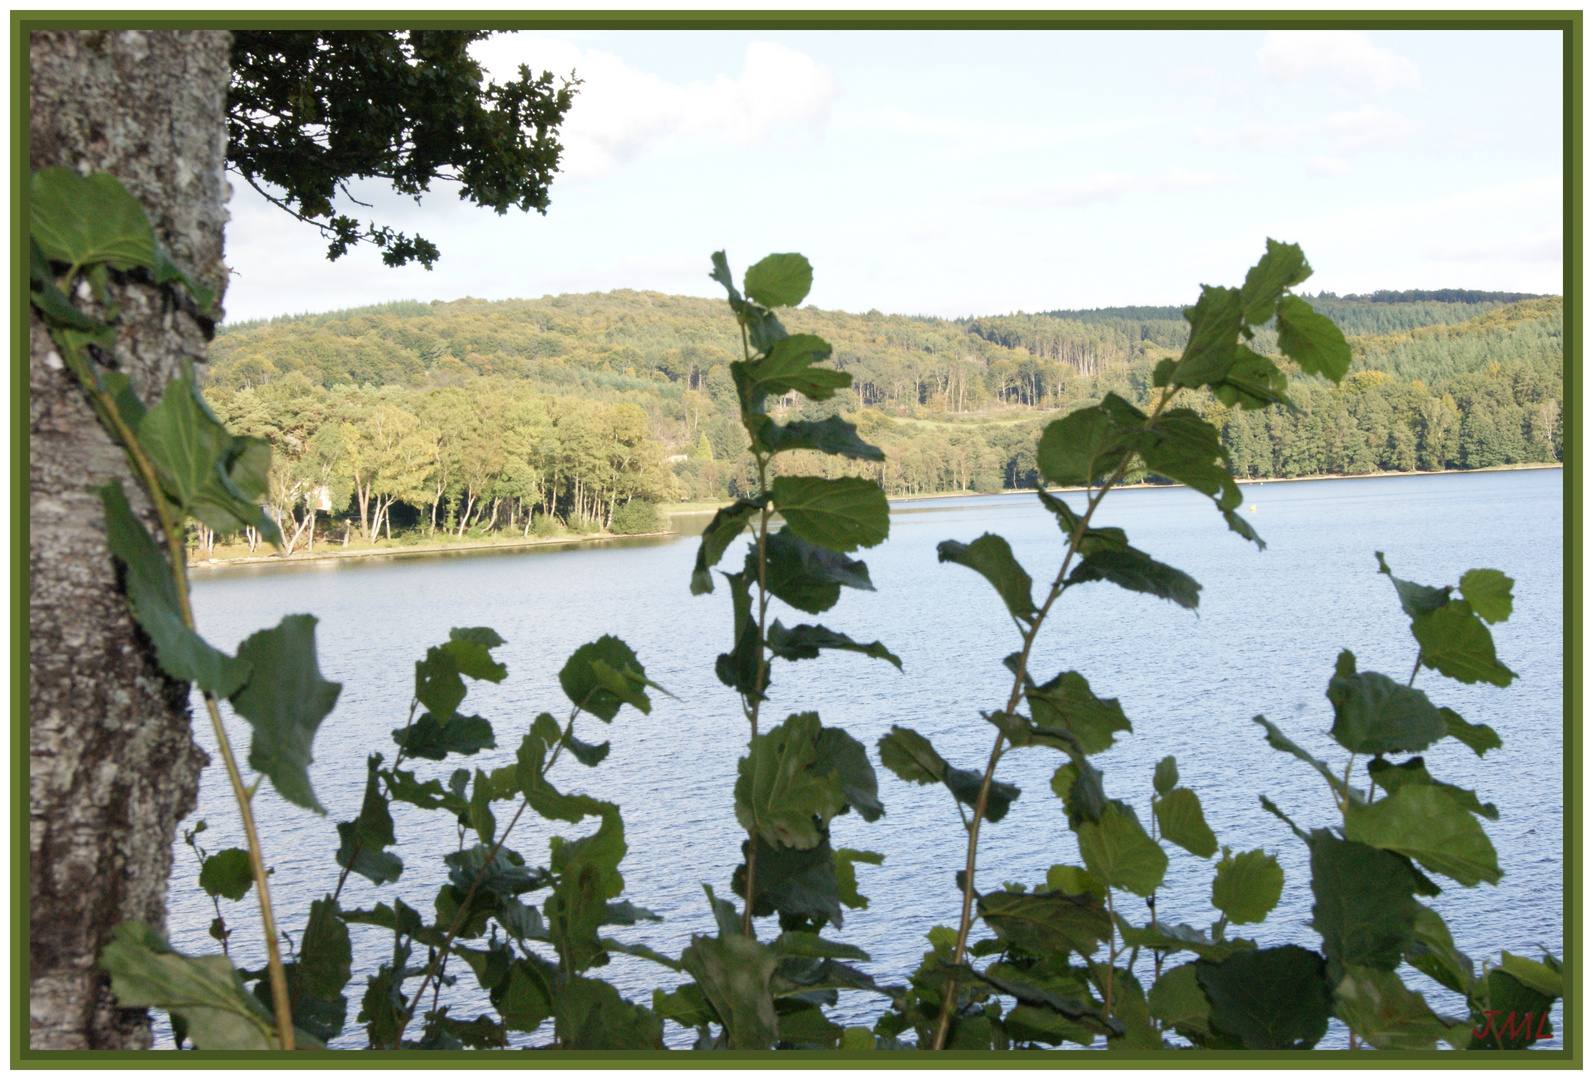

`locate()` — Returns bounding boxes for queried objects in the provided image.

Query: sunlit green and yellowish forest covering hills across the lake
[199,290,1563,551]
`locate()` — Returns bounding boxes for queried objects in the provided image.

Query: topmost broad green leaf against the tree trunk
[29,166,155,269]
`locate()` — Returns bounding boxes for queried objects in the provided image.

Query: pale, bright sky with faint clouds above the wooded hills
[226,30,1564,322]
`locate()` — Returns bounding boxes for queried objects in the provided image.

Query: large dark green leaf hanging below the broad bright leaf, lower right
[1311,828,1421,978]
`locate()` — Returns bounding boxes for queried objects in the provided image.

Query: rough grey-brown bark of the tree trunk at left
[29,30,231,1050]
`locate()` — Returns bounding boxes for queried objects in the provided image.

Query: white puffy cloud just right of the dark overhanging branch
[473,33,841,183]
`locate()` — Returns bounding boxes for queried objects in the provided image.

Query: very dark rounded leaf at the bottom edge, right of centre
[1195,945,1333,1050]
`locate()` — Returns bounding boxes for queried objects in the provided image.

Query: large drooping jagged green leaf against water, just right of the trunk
[231,615,342,814]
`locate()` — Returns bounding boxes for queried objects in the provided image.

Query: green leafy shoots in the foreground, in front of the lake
[32,170,1563,1050]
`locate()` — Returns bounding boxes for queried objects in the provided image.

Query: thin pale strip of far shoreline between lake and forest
[188,462,1564,570]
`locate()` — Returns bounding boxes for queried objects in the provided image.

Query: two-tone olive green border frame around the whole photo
[10,10,1583,1069]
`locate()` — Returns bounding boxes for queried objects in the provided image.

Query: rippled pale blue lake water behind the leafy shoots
[158,470,1564,1048]
